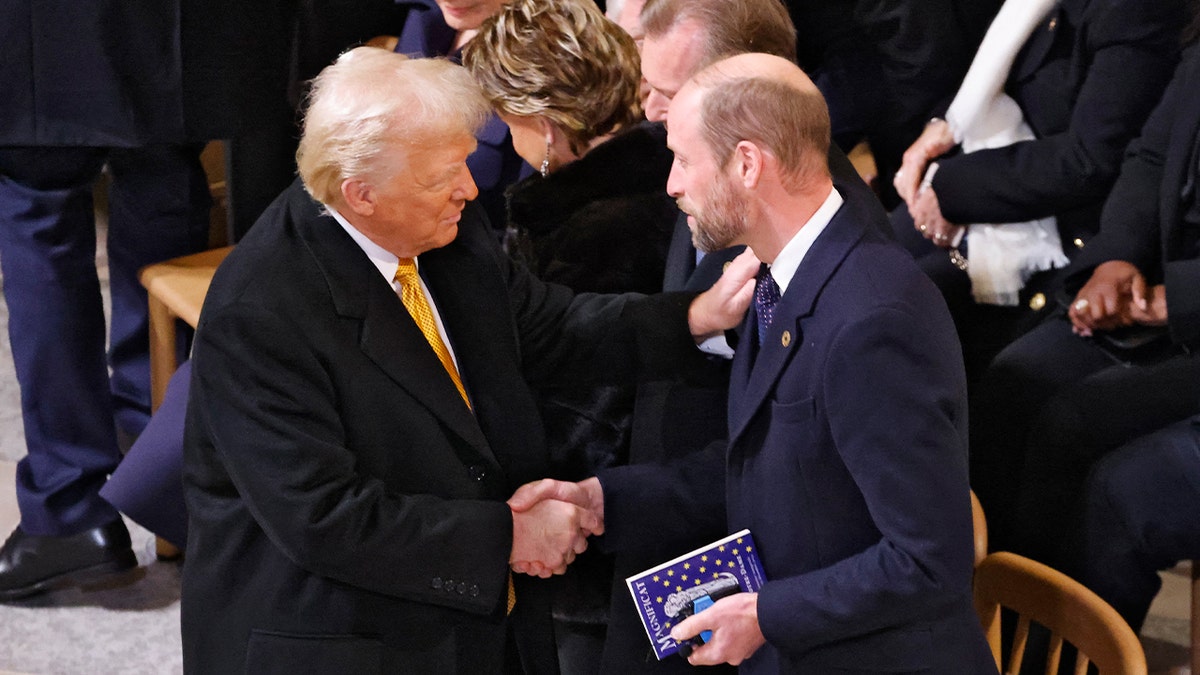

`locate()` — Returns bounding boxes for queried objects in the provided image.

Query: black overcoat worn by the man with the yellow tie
[182,181,691,674]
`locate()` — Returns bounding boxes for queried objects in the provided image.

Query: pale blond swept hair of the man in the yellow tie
[296,47,491,204]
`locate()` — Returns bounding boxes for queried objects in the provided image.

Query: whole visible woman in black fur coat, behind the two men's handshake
[462,0,677,674]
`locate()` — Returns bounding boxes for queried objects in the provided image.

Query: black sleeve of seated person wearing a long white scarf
[934,0,1180,223]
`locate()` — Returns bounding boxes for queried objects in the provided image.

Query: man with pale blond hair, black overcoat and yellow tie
[181,47,745,674]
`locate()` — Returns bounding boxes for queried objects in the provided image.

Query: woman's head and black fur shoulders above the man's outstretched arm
[463,0,674,293]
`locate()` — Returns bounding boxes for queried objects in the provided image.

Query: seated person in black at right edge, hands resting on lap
[971,35,1200,563]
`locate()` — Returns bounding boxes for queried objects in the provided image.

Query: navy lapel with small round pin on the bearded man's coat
[730,189,869,443]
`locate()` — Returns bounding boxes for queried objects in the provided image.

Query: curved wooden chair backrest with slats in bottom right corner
[974,551,1146,675]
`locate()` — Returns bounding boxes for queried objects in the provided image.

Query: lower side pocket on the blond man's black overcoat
[246,631,383,675]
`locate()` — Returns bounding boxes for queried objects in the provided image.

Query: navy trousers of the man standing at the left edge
[0,145,211,534]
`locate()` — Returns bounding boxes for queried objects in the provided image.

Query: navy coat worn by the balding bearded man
[601,187,995,675]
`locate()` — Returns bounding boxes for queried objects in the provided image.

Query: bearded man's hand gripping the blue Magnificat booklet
[671,593,767,665]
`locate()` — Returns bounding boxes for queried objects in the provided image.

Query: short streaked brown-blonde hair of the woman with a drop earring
[462,0,642,153]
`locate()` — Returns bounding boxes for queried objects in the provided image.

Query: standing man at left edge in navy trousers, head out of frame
[0,0,275,601]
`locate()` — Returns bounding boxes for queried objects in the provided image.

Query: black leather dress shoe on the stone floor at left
[0,520,138,602]
